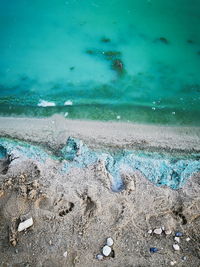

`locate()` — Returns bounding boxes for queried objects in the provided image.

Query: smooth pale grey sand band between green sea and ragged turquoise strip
[0,115,200,153]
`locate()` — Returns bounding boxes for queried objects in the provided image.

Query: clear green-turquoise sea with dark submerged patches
[0,0,200,125]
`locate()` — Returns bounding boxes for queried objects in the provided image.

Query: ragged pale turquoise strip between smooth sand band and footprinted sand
[0,138,200,192]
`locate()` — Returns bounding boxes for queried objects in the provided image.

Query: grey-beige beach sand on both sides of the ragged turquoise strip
[0,116,200,267]
